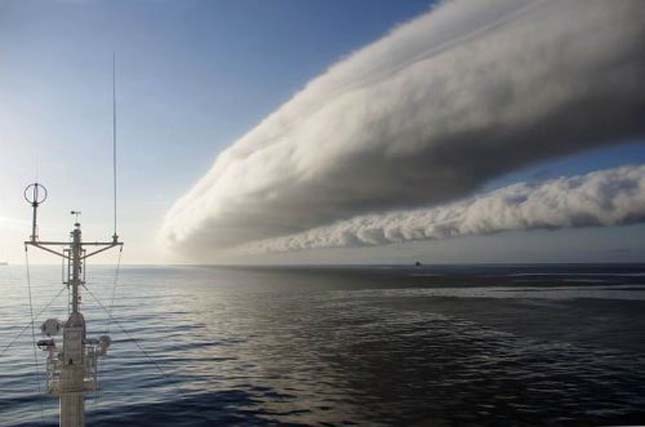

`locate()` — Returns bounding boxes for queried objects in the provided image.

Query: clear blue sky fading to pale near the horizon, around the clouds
[0,0,645,263]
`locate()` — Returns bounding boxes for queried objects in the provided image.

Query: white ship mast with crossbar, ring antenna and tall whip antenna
[24,53,123,427]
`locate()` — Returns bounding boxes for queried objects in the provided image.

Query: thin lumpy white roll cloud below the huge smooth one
[236,166,645,254]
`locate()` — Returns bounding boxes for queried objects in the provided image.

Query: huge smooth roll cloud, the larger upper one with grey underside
[161,0,645,257]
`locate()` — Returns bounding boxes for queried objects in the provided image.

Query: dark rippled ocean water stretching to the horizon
[0,265,645,426]
